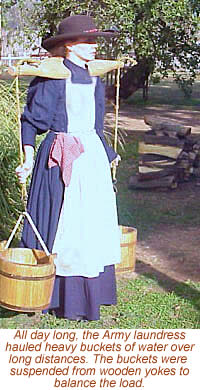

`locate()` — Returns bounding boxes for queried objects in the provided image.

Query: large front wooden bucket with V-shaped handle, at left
[0,213,56,312]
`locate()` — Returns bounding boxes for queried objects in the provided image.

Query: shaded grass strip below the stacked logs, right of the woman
[117,139,200,239]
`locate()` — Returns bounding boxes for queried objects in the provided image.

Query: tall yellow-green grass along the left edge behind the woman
[0,81,24,239]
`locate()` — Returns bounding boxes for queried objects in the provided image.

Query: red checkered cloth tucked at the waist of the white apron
[48,133,84,187]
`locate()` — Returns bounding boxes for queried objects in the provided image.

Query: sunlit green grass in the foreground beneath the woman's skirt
[0,274,200,329]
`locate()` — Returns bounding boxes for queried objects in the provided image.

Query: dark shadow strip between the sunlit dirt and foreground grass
[136,261,200,310]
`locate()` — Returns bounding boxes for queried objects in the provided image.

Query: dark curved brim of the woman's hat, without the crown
[42,31,118,51]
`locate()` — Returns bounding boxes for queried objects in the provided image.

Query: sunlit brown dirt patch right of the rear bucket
[135,226,200,282]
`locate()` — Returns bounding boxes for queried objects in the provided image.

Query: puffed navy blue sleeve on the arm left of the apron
[21,77,58,147]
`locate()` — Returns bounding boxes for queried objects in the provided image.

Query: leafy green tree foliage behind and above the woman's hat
[1,0,200,94]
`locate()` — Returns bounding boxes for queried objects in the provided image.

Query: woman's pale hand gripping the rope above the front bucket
[15,145,34,184]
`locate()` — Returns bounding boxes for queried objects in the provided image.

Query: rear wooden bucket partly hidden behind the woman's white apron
[115,226,137,273]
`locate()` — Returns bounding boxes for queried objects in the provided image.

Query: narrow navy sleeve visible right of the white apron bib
[95,77,117,162]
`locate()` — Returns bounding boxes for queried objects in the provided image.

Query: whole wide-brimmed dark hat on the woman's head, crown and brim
[42,15,117,51]
